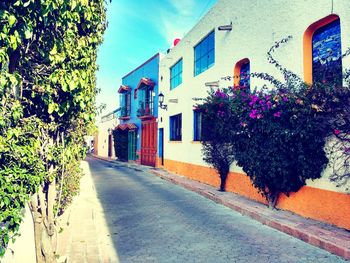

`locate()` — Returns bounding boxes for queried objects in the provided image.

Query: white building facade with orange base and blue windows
[158,0,350,229]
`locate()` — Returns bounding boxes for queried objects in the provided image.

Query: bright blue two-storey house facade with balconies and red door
[115,53,161,166]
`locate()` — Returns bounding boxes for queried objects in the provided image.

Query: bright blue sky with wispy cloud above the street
[97,0,217,117]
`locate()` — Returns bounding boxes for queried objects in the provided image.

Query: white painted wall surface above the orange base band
[158,0,350,194]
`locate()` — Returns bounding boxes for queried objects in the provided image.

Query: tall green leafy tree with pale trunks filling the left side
[0,0,106,261]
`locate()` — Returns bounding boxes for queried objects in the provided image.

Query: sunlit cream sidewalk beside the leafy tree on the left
[57,161,119,263]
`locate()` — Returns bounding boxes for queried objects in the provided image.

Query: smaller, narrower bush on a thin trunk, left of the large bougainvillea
[196,89,239,191]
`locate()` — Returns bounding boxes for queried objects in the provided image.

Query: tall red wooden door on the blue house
[141,119,157,167]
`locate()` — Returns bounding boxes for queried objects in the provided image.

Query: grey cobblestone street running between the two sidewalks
[82,158,345,263]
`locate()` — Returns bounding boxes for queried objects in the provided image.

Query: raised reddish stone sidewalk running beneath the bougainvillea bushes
[94,156,350,260]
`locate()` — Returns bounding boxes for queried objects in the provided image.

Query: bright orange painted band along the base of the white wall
[164,159,350,230]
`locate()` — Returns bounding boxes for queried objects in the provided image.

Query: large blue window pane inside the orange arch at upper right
[312,19,342,85]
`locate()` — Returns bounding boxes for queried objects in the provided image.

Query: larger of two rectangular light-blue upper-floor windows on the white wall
[194,31,215,76]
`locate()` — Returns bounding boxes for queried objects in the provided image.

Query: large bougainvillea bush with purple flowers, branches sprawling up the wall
[203,37,350,207]
